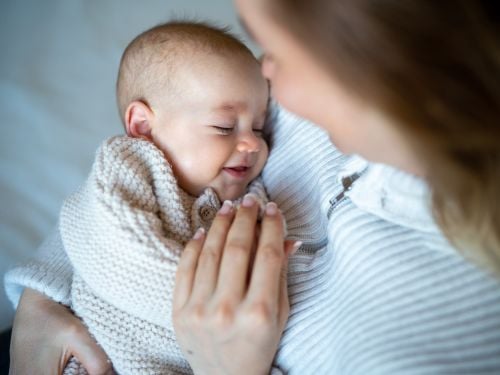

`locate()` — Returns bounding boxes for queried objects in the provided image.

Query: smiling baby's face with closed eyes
[151,55,269,200]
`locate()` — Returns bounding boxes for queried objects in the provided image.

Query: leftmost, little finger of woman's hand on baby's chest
[173,228,205,313]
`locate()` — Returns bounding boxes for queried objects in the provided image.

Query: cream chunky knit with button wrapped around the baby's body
[60,136,266,374]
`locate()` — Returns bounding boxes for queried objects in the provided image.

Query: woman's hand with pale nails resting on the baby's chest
[173,198,292,375]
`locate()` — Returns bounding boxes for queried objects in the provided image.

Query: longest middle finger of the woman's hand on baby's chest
[216,194,259,303]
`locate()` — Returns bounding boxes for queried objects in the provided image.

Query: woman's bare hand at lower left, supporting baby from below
[9,288,113,375]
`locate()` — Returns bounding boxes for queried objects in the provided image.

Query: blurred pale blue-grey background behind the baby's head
[0,0,257,331]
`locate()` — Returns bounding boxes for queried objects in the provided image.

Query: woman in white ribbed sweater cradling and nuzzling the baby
[7,0,500,374]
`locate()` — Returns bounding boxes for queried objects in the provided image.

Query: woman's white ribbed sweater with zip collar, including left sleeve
[5,104,500,375]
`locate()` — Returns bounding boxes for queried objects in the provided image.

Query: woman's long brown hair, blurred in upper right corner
[268,0,500,274]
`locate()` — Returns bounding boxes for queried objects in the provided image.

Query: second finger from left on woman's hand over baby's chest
[191,201,234,302]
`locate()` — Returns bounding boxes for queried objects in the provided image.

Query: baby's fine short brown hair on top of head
[116,20,257,122]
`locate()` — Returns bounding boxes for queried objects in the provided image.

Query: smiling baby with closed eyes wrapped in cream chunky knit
[60,22,269,374]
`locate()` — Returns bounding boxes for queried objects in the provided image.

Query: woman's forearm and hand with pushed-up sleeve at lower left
[5,227,112,375]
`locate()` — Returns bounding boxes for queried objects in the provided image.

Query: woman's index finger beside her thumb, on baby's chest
[248,206,287,306]
